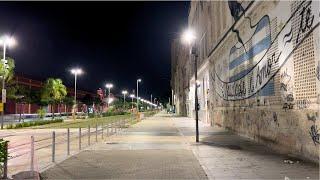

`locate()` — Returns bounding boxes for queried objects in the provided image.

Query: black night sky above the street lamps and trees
[0,2,189,100]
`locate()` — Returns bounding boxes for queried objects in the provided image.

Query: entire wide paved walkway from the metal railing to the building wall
[42,113,319,179]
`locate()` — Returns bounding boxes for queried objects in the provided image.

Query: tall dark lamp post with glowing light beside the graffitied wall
[182,29,199,142]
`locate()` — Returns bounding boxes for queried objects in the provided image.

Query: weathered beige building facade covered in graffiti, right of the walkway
[171,1,320,162]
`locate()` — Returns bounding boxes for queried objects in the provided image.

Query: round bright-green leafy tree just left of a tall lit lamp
[41,78,67,119]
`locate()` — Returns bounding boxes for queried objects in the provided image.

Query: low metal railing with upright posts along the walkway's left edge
[8,118,137,179]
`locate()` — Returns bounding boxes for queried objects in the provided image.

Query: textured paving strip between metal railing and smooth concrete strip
[41,114,207,179]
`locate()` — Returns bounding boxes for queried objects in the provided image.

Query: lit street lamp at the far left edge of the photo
[0,35,16,129]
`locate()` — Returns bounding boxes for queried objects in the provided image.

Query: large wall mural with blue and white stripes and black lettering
[211,1,320,101]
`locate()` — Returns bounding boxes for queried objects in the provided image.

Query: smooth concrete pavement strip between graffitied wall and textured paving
[171,114,319,179]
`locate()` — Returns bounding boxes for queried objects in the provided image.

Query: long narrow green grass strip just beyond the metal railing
[33,114,135,129]
